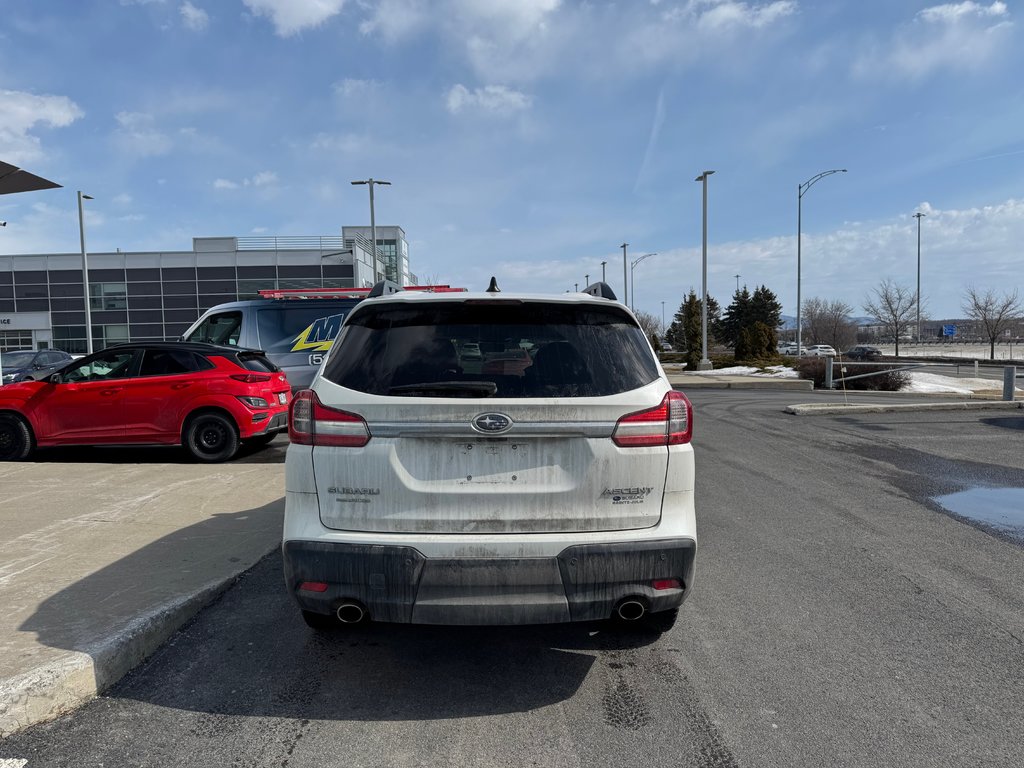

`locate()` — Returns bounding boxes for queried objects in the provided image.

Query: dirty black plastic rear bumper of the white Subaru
[283,539,696,625]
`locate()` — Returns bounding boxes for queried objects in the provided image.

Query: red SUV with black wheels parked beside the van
[0,342,291,462]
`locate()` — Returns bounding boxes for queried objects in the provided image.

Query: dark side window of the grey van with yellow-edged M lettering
[256,299,355,354]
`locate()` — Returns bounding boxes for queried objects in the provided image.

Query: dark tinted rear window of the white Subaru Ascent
[324,301,660,397]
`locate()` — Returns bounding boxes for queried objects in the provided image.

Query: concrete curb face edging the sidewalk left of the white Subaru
[0,549,273,738]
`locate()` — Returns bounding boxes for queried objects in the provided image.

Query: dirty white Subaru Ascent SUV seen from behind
[283,281,696,632]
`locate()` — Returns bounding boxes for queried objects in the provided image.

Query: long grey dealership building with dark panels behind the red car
[0,226,416,353]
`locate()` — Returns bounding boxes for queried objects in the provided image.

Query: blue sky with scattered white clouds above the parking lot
[0,0,1024,318]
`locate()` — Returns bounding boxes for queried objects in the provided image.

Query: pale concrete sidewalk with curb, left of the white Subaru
[0,450,285,737]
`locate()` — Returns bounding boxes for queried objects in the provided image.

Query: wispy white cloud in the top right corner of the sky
[853,0,1013,80]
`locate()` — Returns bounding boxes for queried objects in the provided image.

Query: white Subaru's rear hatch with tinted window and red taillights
[293,299,689,534]
